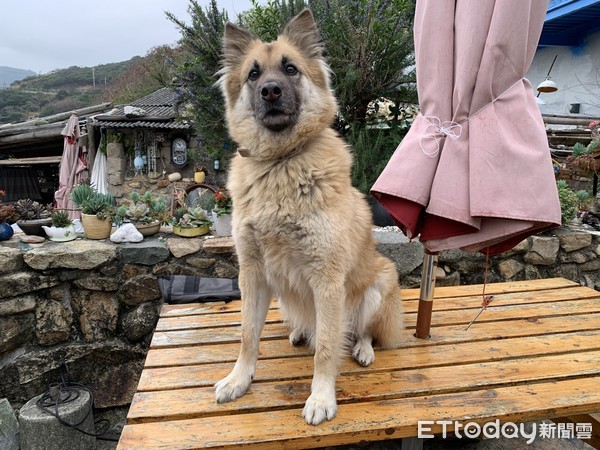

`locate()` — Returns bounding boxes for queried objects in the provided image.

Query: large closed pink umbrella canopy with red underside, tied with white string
[372,0,561,254]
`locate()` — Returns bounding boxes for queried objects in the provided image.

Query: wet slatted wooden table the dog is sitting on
[118,278,600,449]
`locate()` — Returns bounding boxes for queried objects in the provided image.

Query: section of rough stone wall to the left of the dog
[0,234,238,414]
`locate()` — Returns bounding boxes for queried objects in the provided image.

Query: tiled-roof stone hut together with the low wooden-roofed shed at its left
[0,87,227,207]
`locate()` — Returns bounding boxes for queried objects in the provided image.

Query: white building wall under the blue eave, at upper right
[527,32,600,117]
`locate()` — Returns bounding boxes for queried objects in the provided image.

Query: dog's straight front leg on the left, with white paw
[215,265,271,403]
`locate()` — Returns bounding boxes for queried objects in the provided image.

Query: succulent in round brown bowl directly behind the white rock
[115,192,170,236]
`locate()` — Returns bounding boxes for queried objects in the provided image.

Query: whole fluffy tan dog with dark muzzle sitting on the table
[216,10,403,425]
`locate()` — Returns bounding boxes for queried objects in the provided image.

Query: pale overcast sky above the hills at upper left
[0,0,255,73]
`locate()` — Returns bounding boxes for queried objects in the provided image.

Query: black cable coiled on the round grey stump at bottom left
[36,363,118,442]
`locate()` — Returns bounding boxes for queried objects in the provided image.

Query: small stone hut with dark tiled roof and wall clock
[88,87,226,202]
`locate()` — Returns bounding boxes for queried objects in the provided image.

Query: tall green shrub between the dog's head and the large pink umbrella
[308,0,416,125]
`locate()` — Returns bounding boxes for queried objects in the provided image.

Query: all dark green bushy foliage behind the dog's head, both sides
[167,0,416,192]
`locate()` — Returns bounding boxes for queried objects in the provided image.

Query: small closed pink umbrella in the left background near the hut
[54,114,87,219]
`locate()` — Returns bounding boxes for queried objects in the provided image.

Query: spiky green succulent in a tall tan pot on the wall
[71,183,116,239]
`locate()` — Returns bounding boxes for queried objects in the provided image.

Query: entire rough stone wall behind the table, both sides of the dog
[0,228,600,416]
